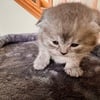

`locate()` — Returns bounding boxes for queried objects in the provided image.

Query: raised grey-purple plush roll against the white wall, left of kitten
[0,33,37,47]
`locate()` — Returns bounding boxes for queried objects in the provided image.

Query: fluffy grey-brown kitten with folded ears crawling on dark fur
[33,3,100,77]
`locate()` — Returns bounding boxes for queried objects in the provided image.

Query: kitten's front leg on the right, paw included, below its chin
[64,59,83,77]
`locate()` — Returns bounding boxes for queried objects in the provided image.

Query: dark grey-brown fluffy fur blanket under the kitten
[0,39,100,100]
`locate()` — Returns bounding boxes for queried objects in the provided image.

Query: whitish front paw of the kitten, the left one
[33,59,49,70]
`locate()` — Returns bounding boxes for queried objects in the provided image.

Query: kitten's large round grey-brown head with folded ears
[37,4,99,56]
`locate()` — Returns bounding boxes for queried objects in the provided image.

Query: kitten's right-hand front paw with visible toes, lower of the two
[64,67,83,77]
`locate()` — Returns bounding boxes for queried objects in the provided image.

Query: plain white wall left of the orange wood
[0,0,37,34]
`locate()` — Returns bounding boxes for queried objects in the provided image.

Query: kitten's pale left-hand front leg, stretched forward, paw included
[33,48,50,70]
